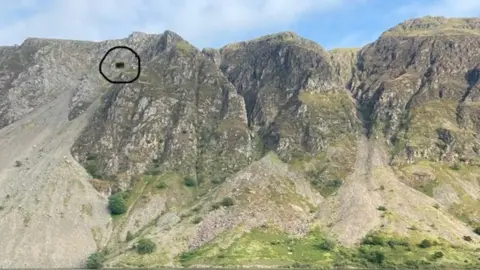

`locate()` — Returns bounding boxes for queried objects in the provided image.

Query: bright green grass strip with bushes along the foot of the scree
[177,228,478,268]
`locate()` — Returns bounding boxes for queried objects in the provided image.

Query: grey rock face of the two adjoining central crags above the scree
[73,33,358,188]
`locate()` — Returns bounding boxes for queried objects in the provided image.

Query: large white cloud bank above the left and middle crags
[0,0,352,46]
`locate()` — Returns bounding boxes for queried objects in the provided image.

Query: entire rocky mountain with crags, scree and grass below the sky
[0,17,480,268]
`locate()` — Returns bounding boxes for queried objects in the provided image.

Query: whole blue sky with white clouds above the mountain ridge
[0,0,480,49]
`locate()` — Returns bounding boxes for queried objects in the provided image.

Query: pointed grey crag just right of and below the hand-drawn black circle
[72,32,254,189]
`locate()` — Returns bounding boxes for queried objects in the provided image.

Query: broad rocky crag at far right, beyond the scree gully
[353,18,480,167]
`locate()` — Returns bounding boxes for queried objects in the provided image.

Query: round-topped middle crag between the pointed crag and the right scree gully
[220,32,359,192]
